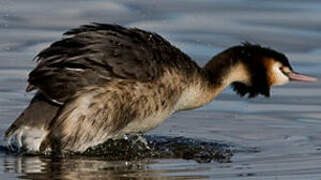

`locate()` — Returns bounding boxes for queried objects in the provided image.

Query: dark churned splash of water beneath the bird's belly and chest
[83,135,233,163]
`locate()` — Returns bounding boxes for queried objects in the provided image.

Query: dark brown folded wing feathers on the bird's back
[28,24,195,102]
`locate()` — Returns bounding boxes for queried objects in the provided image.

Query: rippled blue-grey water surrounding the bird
[0,0,321,180]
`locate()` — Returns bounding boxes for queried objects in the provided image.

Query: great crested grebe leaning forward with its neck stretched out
[6,23,316,152]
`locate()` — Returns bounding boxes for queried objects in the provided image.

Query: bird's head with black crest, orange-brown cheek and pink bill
[230,43,317,97]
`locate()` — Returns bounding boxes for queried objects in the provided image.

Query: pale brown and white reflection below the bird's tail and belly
[4,156,147,179]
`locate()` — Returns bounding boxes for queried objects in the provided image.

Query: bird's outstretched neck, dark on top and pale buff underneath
[175,53,249,110]
